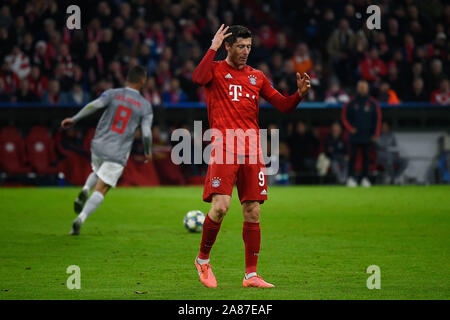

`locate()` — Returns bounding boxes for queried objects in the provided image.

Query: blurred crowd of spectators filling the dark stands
[0,0,450,105]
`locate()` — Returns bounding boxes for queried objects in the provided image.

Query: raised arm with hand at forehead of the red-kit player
[192,24,231,86]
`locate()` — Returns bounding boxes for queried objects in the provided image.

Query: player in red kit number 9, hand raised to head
[192,25,311,287]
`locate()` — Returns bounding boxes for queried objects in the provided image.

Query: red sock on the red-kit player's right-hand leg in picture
[242,221,261,274]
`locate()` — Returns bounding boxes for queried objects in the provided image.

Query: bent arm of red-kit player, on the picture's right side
[261,72,311,113]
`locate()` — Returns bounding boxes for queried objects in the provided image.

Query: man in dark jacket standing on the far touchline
[342,80,381,187]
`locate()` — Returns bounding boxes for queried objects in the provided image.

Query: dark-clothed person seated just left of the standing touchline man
[324,122,350,184]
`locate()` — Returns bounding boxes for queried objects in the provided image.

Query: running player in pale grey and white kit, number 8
[61,66,153,235]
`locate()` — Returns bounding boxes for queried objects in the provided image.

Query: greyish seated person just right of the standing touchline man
[376,122,408,184]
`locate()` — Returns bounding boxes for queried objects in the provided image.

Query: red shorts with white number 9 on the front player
[203,163,267,203]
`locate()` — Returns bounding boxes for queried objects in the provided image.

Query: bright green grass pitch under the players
[0,186,450,300]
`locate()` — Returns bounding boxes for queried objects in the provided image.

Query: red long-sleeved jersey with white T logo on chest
[192,49,301,155]
